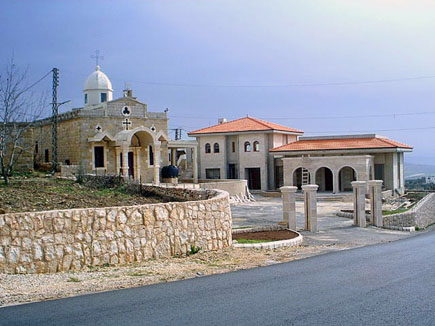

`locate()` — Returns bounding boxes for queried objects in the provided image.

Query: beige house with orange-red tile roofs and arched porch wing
[189,117,412,194]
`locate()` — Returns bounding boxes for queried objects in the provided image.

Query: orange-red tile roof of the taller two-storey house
[189,117,303,136]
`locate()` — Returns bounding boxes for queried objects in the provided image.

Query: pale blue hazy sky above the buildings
[0,0,435,165]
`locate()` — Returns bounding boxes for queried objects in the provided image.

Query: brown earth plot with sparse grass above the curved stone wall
[0,178,162,214]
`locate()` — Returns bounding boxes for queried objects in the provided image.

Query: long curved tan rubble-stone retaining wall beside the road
[0,191,232,273]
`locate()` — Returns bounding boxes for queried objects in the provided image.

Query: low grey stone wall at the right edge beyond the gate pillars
[384,193,435,229]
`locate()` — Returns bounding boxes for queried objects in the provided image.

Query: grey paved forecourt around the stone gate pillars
[231,195,417,247]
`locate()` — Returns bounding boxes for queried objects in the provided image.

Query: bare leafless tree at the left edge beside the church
[0,59,47,185]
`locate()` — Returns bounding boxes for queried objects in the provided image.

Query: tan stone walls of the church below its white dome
[26,97,169,182]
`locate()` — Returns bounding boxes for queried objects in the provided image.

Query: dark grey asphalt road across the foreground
[0,232,435,326]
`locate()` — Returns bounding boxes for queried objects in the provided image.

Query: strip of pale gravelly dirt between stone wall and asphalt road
[0,244,349,306]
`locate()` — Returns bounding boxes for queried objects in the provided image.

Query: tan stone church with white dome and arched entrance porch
[20,66,197,184]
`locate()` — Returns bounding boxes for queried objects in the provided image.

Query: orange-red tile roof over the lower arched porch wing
[271,137,412,152]
